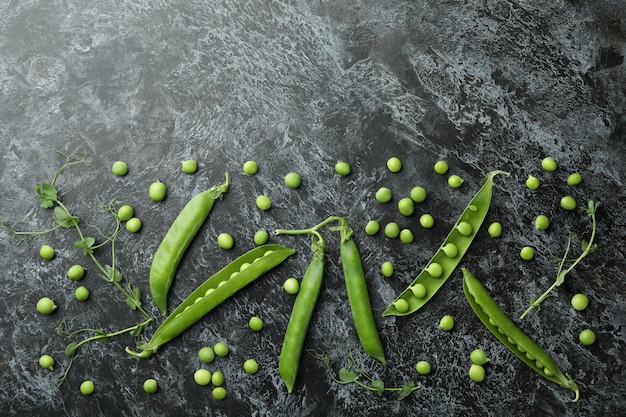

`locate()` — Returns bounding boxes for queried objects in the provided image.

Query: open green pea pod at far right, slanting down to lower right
[462,268,580,401]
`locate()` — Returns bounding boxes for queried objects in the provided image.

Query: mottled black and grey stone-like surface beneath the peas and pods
[0,0,626,416]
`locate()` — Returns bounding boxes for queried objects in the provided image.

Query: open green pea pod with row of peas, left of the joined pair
[126,244,295,358]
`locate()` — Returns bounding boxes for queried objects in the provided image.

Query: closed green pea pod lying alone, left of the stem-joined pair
[150,174,230,314]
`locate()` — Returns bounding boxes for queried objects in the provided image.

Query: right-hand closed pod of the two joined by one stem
[339,219,387,365]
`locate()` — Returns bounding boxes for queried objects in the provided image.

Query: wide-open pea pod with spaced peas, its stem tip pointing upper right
[383,170,509,316]
